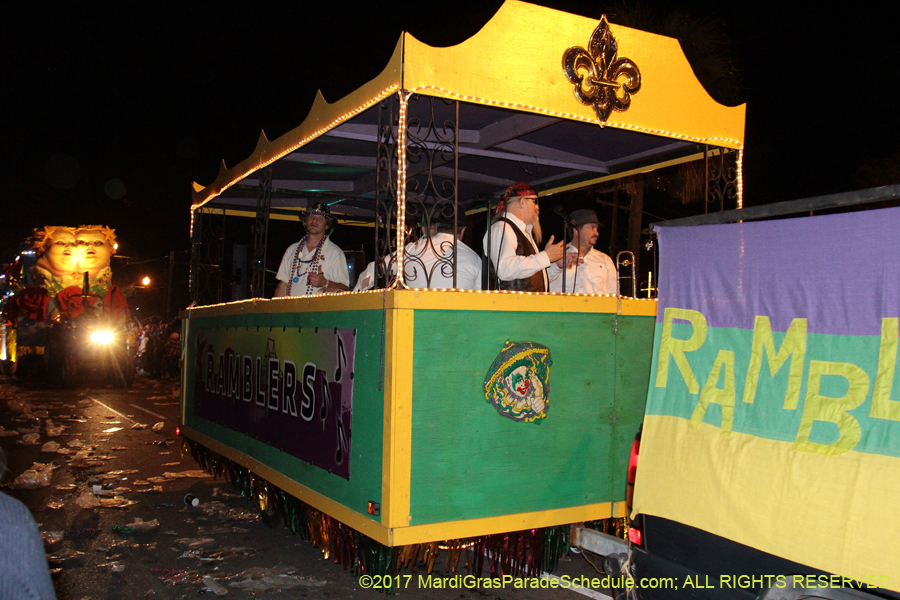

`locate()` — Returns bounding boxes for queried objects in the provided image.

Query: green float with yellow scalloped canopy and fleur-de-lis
[181,0,745,573]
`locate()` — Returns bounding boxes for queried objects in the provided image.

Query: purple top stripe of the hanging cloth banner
[657,208,900,336]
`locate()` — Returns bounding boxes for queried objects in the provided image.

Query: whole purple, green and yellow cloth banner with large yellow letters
[634,209,900,590]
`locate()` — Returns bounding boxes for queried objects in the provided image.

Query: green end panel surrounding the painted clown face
[410,310,654,525]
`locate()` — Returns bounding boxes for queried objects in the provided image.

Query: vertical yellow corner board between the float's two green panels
[381,309,415,527]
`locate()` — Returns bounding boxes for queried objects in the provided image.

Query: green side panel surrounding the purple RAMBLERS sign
[185,310,384,520]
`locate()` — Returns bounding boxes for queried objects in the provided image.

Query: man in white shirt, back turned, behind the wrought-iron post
[353,218,481,291]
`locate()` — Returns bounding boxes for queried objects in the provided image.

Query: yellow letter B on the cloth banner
[794,360,869,456]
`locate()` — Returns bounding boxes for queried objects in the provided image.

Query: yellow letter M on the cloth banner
[744,316,806,410]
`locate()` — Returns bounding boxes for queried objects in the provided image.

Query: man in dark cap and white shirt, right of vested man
[549,210,619,294]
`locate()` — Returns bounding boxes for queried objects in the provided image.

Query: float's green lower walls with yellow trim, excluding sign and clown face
[182,290,656,545]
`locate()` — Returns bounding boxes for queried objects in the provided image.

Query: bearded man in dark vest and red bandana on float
[484,183,577,292]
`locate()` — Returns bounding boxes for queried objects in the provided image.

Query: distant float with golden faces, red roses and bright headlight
[2,225,134,386]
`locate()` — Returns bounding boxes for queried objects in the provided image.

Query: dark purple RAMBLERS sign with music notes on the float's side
[193,327,356,479]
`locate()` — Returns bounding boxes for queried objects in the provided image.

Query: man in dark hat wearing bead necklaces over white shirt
[275,202,350,298]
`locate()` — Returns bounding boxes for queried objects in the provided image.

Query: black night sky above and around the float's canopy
[0,0,900,270]
